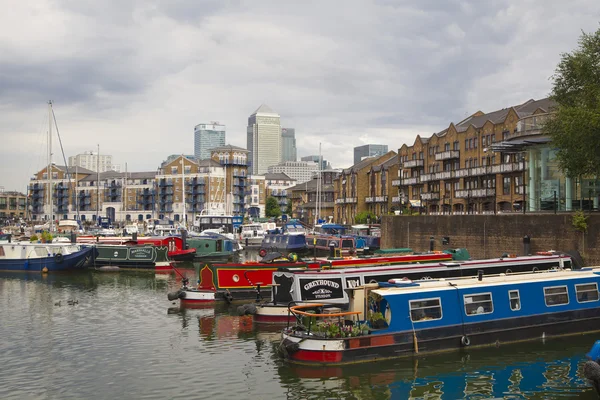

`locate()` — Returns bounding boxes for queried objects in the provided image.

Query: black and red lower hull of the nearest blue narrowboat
[280,310,600,365]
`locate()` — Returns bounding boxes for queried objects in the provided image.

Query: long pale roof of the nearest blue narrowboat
[373,267,600,296]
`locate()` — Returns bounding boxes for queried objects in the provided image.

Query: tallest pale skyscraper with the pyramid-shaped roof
[247,104,281,175]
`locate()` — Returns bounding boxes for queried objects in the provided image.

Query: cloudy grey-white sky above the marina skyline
[0,0,600,192]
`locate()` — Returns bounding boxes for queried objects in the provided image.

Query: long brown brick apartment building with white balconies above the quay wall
[392,98,576,214]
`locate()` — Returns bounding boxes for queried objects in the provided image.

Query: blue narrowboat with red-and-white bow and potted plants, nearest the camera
[279,268,600,365]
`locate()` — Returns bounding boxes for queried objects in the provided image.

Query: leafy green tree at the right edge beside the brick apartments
[544,29,600,178]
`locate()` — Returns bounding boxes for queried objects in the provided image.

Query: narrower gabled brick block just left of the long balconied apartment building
[334,151,397,224]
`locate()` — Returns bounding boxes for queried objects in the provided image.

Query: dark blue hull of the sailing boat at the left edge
[0,248,93,272]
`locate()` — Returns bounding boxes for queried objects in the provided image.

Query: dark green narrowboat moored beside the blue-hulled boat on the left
[91,243,172,270]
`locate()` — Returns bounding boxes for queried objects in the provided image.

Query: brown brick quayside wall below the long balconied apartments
[381,213,600,266]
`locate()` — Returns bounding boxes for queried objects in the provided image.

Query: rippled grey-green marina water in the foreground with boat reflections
[0,271,598,400]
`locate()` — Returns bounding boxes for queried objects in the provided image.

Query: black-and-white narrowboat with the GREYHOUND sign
[254,249,572,323]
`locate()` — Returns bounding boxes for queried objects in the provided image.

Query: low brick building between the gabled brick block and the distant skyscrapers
[286,170,340,225]
